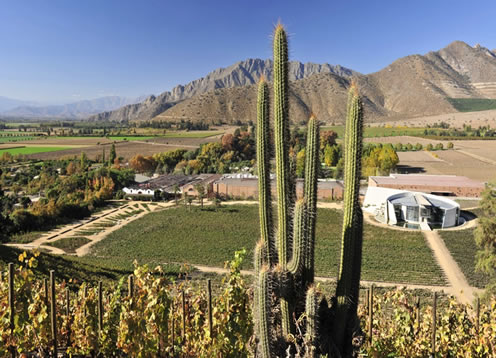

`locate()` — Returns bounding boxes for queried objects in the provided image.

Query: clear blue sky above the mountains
[0,0,496,103]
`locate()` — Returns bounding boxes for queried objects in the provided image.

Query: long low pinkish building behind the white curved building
[369,174,485,197]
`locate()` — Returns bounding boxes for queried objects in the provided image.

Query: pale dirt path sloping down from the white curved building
[422,230,480,304]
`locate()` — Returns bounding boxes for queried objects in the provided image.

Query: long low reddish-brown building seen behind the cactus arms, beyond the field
[213,174,344,200]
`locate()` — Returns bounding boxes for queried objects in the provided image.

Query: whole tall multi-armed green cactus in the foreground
[254,25,362,357]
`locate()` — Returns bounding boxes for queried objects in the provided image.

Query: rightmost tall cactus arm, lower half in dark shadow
[333,85,363,352]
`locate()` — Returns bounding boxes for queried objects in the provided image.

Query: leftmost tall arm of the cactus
[257,77,277,266]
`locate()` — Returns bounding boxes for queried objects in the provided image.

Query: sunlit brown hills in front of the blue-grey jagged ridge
[155,41,496,123]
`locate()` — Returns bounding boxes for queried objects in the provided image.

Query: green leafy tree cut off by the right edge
[474,182,496,295]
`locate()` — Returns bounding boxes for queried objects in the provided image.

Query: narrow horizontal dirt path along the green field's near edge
[191,265,452,294]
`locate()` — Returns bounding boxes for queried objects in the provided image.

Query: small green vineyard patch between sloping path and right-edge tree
[440,229,488,288]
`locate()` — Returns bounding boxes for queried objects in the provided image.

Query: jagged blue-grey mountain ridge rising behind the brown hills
[90,59,358,121]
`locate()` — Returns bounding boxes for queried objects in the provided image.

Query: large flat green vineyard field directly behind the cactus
[87,205,445,284]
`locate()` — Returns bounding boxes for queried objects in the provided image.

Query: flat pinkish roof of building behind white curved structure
[370,174,484,188]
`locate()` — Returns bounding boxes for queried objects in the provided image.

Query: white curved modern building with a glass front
[363,186,460,230]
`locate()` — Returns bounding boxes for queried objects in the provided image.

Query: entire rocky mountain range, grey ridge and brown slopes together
[93,41,496,123]
